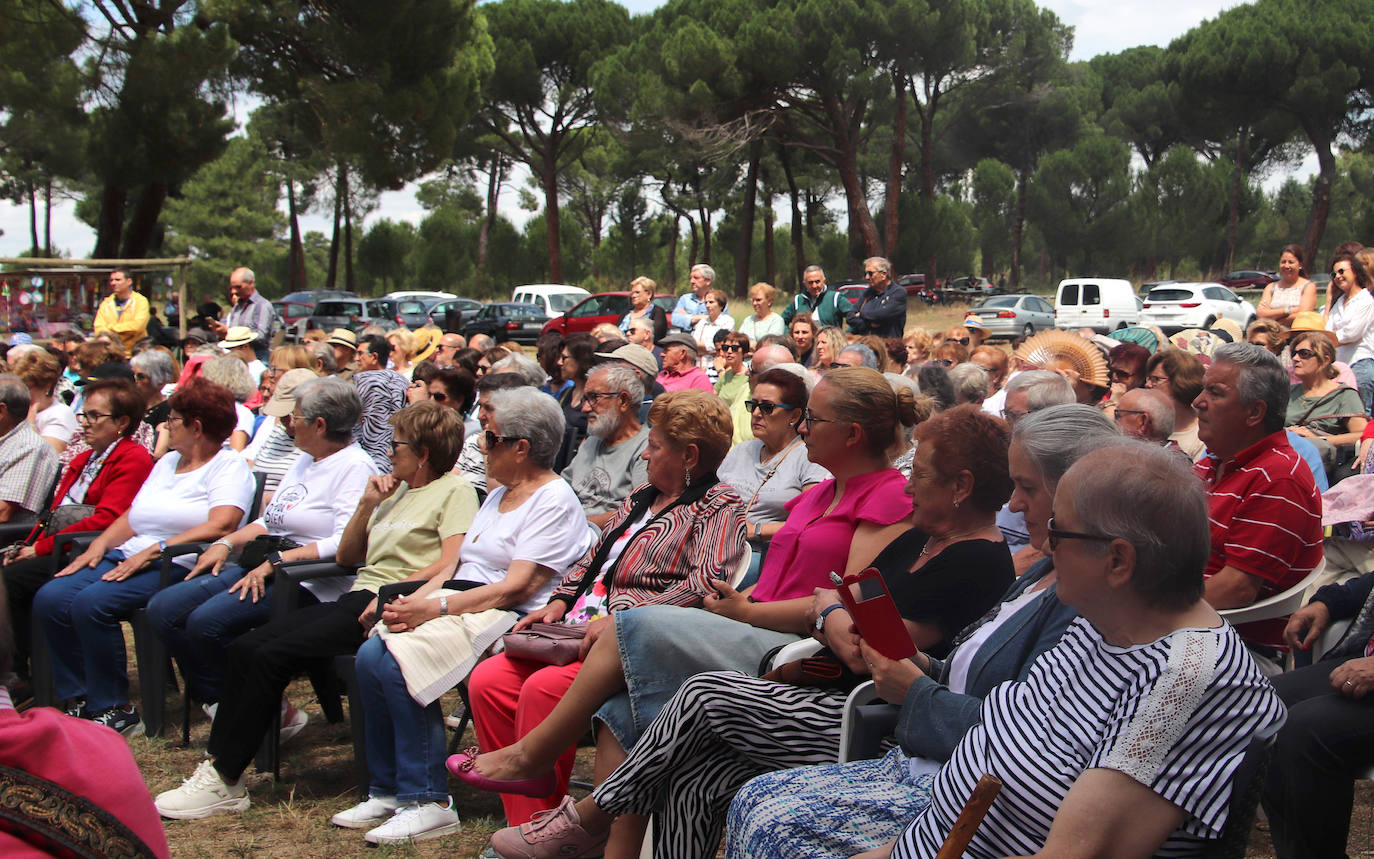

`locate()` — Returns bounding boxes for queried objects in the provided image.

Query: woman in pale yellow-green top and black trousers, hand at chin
[157,403,477,825]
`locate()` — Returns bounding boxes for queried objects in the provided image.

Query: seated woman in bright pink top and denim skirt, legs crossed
[448,367,916,824]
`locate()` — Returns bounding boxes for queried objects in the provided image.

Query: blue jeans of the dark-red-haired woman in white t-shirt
[33,553,158,713]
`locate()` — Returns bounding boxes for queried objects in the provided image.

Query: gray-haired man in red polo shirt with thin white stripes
[1193,344,1322,647]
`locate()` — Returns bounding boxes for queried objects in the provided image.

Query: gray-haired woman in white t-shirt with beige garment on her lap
[341,388,591,844]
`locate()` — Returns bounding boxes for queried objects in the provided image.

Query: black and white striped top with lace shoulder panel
[893,617,1283,859]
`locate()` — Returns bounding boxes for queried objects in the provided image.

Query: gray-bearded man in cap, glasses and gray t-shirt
[563,363,649,528]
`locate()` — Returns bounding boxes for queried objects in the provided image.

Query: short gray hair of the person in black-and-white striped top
[1066,442,1209,610]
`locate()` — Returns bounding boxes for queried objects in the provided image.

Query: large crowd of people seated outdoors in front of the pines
[0,246,1374,858]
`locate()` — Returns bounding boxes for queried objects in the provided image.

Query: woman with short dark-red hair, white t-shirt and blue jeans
[33,379,253,734]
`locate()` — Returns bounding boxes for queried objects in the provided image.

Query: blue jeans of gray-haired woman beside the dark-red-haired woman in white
[148,564,272,702]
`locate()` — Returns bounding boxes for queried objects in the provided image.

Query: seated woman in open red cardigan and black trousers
[0,379,153,687]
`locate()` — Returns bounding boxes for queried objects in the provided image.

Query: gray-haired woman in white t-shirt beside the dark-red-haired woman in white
[148,378,378,723]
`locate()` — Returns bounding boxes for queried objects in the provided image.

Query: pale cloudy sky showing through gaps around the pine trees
[0,0,1247,257]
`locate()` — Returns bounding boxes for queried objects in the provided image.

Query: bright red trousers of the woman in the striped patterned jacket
[467,653,583,826]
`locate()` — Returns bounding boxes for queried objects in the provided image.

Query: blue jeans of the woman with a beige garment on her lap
[354,638,448,803]
